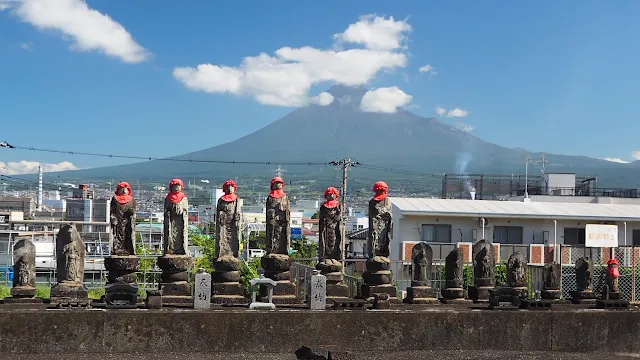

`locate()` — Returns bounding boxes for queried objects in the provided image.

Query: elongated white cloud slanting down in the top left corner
[6,0,149,63]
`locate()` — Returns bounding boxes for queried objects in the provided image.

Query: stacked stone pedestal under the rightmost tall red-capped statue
[360,256,400,304]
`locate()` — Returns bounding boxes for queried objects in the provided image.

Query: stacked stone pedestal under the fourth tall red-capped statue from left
[260,254,300,305]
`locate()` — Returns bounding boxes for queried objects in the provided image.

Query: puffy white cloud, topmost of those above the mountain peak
[333,14,411,51]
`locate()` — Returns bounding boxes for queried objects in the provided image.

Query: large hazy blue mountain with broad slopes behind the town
[48,86,640,187]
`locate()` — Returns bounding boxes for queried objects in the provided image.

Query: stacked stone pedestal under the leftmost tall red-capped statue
[104,255,140,309]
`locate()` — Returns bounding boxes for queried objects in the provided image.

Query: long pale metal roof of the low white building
[390,197,640,221]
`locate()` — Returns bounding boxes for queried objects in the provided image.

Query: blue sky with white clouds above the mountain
[0,0,640,173]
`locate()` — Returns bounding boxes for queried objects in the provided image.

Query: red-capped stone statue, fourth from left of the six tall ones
[266,177,291,255]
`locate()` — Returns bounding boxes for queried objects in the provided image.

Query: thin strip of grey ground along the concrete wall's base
[8,350,640,360]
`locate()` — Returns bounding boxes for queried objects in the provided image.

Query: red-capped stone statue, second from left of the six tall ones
[163,179,189,255]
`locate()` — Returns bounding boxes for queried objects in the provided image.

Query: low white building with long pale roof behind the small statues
[391,196,640,264]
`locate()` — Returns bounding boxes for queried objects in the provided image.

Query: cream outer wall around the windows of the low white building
[390,211,640,260]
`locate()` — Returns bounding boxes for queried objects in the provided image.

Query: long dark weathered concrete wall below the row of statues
[0,310,640,356]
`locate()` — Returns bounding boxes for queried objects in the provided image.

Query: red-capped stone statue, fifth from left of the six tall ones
[318,187,344,262]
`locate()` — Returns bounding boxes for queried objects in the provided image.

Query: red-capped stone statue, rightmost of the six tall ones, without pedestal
[367,181,392,258]
